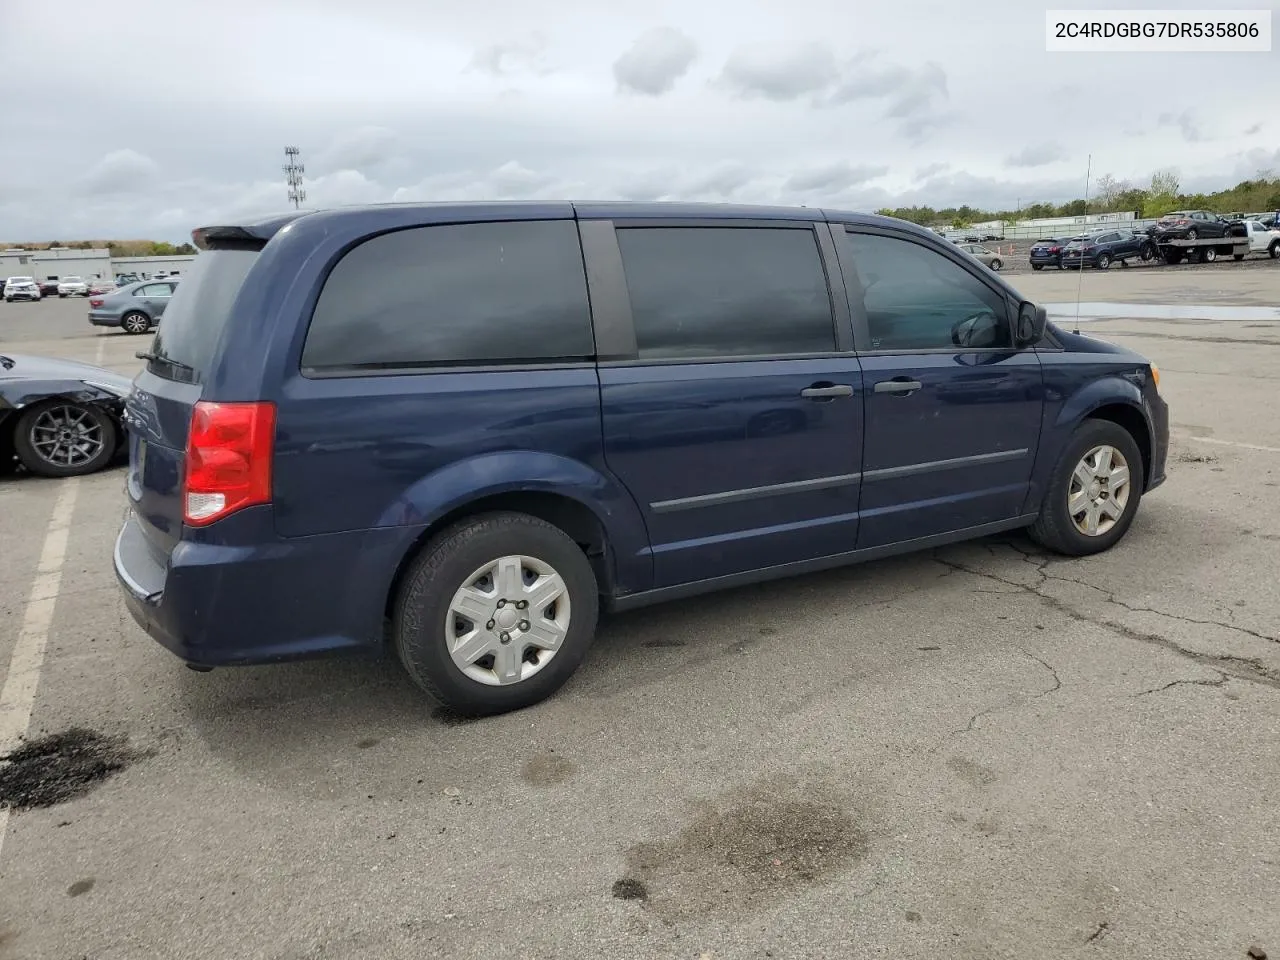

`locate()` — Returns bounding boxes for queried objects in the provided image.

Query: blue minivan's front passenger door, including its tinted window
[837,227,1043,547]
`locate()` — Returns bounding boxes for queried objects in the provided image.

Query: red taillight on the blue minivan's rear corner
[182,401,275,526]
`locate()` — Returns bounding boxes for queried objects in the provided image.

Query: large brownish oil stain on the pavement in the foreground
[614,788,868,916]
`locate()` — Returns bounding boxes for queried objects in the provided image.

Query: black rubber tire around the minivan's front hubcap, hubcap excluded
[1030,420,1144,557]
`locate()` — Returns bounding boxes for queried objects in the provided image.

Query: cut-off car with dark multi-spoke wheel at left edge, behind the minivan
[0,353,132,476]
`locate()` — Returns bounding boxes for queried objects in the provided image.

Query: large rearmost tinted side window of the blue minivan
[302,220,595,370]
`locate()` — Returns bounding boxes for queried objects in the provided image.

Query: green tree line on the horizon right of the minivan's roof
[877,170,1280,228]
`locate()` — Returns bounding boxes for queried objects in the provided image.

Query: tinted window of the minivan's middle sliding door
[617,227,836,360]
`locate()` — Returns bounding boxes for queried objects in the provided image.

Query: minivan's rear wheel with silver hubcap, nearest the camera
[392,512,599,716]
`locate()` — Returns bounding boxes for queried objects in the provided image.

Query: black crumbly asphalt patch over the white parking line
[0,727,142,810]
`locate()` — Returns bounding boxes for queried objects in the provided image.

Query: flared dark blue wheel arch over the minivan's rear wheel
[379,449,653,593]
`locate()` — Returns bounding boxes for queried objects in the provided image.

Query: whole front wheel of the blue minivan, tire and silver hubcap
[1030,420,1144,557]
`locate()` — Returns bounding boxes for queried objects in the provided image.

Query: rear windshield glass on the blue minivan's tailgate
[147,250,257,383]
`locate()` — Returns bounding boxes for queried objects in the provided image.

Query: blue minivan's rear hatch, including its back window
[124,252,257,562]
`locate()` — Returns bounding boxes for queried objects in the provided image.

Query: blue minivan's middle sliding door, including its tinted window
[589,220,863,586]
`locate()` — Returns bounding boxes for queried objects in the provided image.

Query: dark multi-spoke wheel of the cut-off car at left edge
[13,399,119,476]
